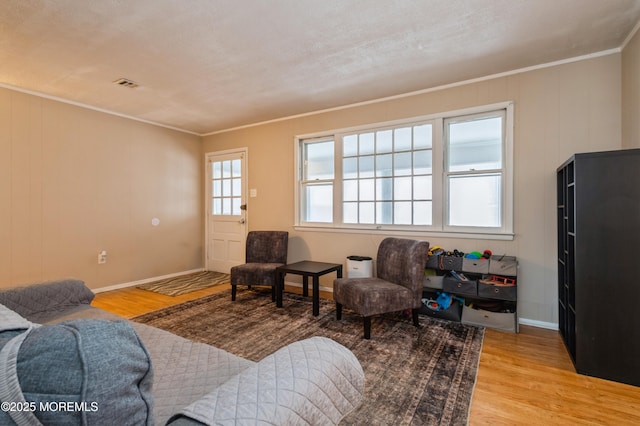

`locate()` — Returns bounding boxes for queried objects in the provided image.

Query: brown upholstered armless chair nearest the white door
[231,231,289,302]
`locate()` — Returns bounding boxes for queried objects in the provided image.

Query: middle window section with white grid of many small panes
[342,124,433,225]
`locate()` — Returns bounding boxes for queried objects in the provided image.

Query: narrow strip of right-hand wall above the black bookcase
[622,27,640,149]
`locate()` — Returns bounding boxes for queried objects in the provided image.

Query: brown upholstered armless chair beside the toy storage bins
[333,238,429,339]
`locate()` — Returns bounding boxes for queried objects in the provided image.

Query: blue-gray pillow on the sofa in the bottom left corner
[0,319,153,425]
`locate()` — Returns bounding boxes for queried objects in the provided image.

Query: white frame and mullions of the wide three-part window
[294,101,514,240]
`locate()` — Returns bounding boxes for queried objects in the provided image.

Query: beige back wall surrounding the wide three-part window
[203,54,621,323]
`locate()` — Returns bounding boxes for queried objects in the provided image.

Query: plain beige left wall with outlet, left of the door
[0,88,203,288]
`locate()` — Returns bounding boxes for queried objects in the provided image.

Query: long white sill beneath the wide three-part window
[293,225,515,241]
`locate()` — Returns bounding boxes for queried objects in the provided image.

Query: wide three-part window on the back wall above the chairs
[296,103,513,235]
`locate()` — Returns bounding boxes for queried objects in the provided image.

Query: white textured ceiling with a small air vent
[0,0,640,134]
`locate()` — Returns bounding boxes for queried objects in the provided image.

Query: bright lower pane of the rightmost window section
[448,174,502,227]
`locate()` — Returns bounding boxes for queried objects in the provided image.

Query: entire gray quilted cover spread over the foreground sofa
[0,279,364,425]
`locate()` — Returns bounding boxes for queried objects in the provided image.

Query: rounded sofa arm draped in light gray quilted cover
[168,337,364,425]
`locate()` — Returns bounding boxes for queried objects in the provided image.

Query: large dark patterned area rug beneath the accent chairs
[134,289,484,425]
